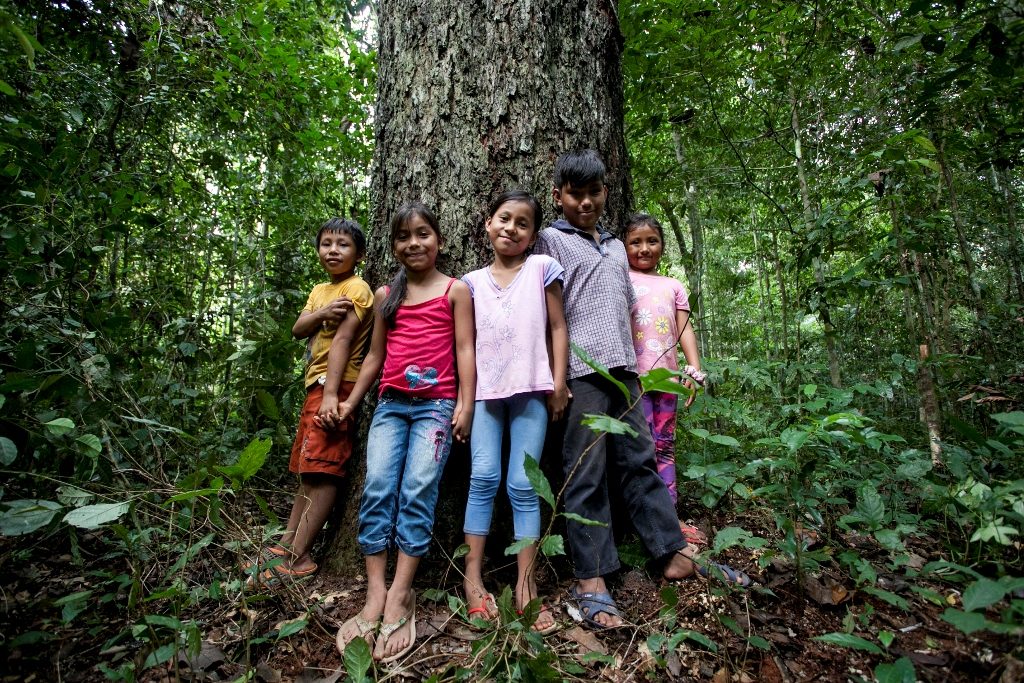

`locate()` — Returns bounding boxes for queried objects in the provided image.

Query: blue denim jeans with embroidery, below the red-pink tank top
[358,391,455,557]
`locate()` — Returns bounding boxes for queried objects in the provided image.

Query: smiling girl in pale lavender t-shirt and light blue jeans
[463,190,568,634]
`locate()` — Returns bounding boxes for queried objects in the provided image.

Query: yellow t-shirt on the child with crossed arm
[302,275,374,389]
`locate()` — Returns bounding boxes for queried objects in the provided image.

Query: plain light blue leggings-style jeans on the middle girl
[463,392,548,541]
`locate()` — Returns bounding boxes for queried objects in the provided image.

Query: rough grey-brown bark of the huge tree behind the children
[327,0,632,570]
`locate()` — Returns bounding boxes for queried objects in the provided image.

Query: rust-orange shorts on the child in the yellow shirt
[288,382,355,477]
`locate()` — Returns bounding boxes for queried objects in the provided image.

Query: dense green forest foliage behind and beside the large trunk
[0,0,1024,680]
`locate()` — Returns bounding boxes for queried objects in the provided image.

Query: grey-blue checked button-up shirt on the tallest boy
[534,220,637,380]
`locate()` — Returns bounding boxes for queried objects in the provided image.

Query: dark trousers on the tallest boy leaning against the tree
[562,369,686,579]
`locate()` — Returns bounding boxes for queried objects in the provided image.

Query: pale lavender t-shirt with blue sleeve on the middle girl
[462,254,563,400]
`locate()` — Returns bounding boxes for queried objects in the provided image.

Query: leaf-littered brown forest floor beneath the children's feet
[0,509,1024,683]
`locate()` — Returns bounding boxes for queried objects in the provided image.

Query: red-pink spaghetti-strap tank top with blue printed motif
[380,278,458,398]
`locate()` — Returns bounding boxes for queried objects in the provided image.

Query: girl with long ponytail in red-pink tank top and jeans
[337,202,476,663]
